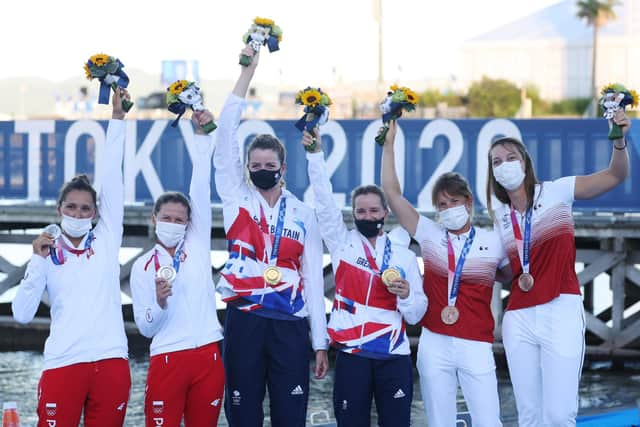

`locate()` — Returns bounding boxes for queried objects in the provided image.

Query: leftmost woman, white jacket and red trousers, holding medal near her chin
[11,88,131,427]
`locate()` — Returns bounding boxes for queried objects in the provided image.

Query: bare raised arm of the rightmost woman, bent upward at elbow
[574,109,631,199]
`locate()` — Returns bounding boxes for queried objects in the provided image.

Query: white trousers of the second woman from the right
[417,328,502,427]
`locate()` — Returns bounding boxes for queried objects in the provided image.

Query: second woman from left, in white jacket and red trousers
[131,111,224,427]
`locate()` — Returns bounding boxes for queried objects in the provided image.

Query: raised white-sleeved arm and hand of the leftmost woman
[96,88,130,251]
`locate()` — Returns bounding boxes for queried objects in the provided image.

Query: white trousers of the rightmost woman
[502,294,585,427]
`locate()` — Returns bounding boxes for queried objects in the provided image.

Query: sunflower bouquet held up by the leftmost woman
[84,53,133,112]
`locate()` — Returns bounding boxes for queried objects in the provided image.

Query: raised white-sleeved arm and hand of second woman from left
[187,111,214,255]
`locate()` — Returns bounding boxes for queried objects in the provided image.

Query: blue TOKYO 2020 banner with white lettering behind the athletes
[0,119,640,211]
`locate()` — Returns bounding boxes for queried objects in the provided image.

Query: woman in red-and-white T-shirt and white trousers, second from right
[381,122,509,427]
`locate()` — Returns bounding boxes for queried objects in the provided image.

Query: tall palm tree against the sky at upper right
[576,0,620,117]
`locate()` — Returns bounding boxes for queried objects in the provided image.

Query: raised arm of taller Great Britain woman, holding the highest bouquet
[213,48,259,203]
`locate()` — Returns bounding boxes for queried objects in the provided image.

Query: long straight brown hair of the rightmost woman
[487,137,538,218]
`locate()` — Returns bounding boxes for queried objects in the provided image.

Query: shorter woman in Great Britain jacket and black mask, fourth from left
[302,132,427,427]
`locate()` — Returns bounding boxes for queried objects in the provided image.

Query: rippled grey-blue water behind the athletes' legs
[0,351,640,427]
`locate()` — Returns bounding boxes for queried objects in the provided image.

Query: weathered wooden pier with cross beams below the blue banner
[0,203,640,358]
